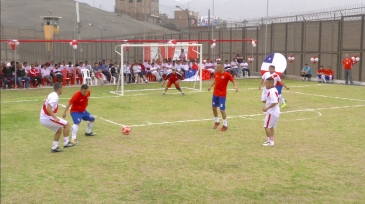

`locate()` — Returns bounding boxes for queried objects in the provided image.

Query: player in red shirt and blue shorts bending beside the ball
[62,84,96,144]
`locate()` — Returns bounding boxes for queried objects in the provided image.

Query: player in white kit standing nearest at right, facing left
[262,78,280,146]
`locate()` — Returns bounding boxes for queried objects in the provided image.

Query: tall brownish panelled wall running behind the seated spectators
[1,15,365,81]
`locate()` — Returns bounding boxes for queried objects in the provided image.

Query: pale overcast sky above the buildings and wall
[77,0,365,21]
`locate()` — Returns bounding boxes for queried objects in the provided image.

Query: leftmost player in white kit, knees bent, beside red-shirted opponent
[40,83,74,153]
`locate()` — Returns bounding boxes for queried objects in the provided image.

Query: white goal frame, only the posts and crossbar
[110,42,203,96]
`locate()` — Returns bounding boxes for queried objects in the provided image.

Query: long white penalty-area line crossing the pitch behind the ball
[95,105,365,127]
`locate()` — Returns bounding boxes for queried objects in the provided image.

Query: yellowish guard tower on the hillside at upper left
[41,16,62,53]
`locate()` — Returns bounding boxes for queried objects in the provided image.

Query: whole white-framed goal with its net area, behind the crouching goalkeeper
[110,42,203,96]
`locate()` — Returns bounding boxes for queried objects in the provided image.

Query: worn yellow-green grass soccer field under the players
[1,79,365,203]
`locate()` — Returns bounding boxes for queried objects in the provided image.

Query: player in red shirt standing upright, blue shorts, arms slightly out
[208,64,238,131]
